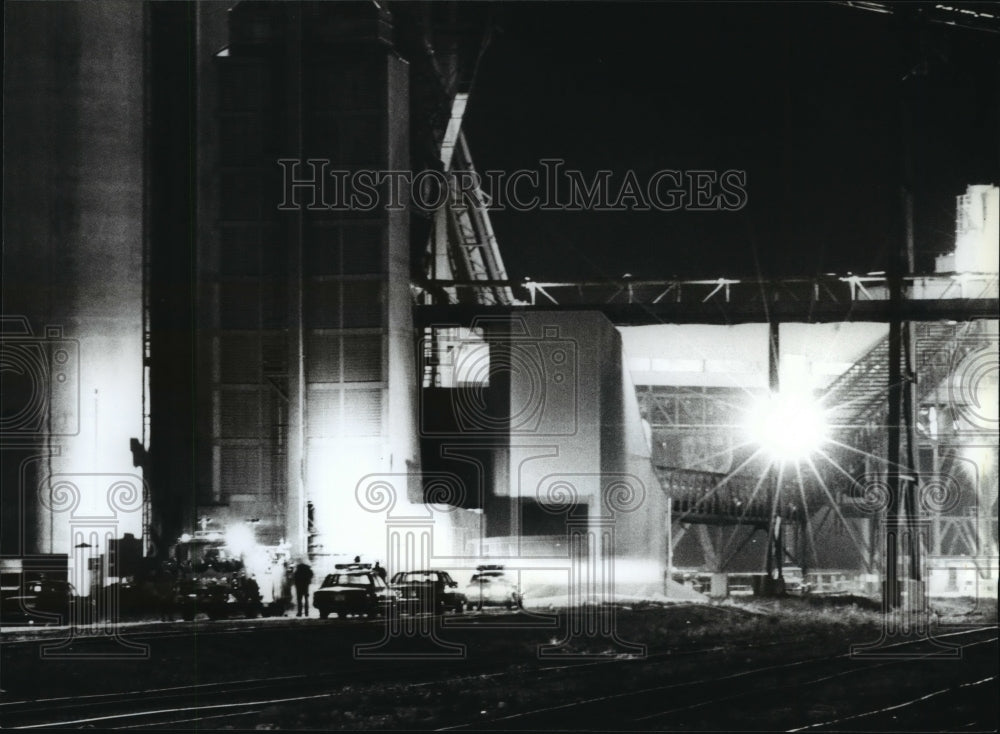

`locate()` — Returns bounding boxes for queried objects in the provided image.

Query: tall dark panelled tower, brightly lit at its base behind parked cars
[198,3,419,556]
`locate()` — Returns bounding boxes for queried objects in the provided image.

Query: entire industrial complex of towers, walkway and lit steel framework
[2,2,1000,608]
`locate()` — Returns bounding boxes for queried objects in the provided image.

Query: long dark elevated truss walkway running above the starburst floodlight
[413,273,1000,326]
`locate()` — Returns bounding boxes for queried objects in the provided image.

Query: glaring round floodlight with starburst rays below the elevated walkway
[747,393,827,461]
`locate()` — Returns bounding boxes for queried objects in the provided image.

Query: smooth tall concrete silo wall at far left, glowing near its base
[0,2,145,565]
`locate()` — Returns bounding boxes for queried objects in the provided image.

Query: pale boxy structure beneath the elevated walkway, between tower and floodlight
[487,312,666,583]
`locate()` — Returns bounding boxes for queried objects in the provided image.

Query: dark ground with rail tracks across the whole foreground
[0,597,1000,732]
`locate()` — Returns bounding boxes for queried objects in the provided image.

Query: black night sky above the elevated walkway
[465,3,1000,280]
